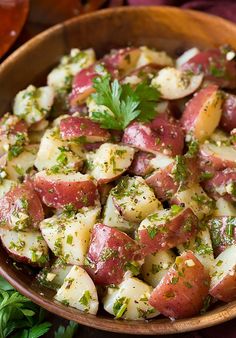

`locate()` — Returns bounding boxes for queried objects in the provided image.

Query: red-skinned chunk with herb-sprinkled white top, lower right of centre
[138,205,198,254]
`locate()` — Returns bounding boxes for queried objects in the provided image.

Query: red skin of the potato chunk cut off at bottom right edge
[209,267,236,303]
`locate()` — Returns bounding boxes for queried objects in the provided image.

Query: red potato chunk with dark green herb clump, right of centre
[146,156,199,200]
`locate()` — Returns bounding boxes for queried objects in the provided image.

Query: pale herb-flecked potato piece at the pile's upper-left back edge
[47,48,96,94]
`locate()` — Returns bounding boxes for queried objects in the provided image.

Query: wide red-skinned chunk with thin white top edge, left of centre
[34,170,98,209]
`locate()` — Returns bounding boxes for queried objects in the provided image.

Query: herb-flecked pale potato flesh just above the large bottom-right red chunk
[177,228,214,275]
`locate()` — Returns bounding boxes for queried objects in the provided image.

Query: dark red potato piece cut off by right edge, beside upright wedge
[220,94,236,133]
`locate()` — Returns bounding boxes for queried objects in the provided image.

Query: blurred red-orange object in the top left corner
[0,0,29,57]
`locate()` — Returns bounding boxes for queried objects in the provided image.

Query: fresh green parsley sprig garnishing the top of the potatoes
[91,75,160,130]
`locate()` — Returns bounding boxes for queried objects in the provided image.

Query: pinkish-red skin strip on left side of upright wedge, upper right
[180,84,218,133]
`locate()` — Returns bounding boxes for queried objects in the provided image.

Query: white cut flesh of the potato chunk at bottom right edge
[210,245,236,289]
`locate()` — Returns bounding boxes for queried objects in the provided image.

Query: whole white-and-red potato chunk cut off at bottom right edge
[210,244,236,302]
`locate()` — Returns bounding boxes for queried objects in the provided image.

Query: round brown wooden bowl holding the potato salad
[0,7,236,335]
